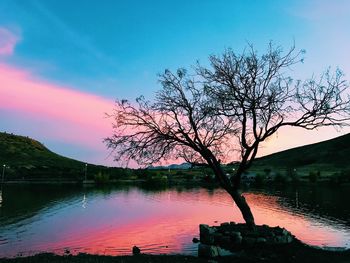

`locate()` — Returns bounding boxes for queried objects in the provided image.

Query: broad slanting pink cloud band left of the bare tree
[0,64,114,158]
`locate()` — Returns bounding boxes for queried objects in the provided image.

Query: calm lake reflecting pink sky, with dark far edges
[0,185,350,257]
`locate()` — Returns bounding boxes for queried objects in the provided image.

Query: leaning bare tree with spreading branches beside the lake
[105,44,350,227]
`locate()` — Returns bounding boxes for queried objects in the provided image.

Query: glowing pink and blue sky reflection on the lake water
[0,189,350,256]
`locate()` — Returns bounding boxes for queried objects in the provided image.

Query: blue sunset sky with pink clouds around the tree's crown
[0,0,350,165]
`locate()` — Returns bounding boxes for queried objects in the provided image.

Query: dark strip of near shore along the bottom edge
[0,241,350,263]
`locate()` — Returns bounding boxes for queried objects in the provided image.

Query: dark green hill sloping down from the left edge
[0,132,128,180]
